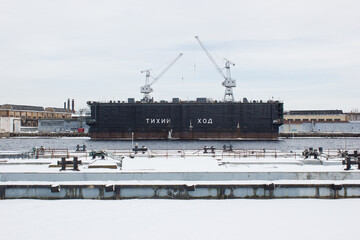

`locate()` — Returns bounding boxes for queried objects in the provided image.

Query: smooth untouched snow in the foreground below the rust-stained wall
[0,199,360,240]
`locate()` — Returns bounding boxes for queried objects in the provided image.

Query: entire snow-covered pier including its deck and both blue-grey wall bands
[0,148,360,199]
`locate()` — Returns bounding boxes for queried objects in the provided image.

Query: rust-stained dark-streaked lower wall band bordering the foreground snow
[0,183,360,200]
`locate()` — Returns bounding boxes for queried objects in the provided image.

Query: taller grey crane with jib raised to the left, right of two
[195,36,236,102]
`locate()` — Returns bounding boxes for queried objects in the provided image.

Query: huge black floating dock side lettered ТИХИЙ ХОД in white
[88,102,283,140]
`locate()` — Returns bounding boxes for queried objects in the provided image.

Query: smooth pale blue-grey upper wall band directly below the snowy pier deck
[0,170,360,183]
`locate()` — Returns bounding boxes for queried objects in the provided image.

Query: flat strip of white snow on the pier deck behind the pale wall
[0,156,348,172]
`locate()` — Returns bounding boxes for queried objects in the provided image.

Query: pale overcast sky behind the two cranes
[0,0,360,111]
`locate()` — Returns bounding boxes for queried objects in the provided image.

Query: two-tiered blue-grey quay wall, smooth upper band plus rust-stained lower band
[0,170,360,199]
